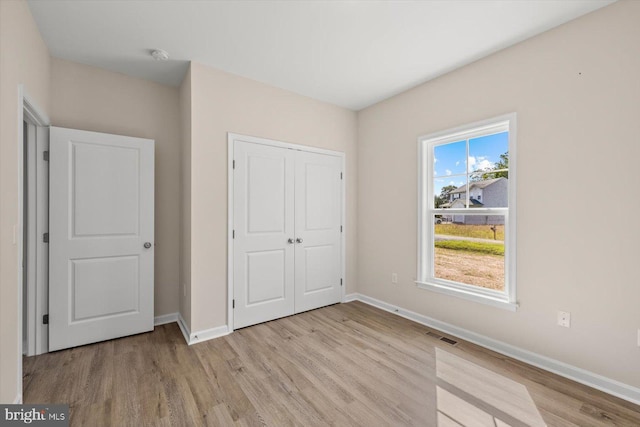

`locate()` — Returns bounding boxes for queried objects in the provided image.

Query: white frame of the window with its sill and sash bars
[415,113,518,311]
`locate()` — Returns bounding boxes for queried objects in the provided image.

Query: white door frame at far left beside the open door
[13,84,50,403]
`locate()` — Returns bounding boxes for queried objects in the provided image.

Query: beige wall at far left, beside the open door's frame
[0,0,50,403]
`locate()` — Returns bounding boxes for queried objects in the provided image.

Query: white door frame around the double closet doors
[227,132,347,333]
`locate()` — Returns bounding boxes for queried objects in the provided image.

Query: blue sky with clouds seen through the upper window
[433,132,509,196]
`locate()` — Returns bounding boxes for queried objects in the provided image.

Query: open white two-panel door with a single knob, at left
[49,127,154,351]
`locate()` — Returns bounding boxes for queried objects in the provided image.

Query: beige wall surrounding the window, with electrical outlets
[358,2,640,387]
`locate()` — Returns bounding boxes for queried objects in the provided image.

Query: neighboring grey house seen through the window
[442,178,509,225]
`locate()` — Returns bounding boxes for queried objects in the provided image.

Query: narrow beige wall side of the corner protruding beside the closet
[179,66,191,328]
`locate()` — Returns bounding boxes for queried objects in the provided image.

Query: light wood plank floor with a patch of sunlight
[24,302,640,427]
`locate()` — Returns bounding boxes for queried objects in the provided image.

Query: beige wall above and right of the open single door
[51,58,181,316]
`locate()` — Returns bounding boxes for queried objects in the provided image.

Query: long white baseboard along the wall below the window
[344,293,640,405]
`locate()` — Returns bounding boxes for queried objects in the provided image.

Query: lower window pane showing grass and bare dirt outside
[433,215,505,291]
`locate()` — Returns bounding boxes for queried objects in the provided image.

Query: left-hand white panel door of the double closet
[233,141,295,328]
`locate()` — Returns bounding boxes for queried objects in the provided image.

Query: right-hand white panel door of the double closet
[295,151,342,313]
